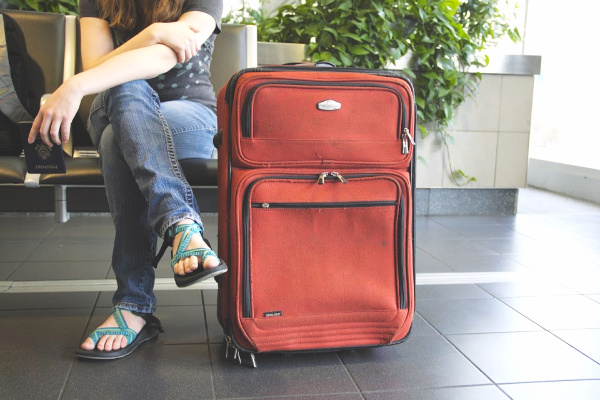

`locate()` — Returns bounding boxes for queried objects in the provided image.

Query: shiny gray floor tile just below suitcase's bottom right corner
[341,336,490,392]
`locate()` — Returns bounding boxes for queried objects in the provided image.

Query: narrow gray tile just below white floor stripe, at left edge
[0,292,98,310]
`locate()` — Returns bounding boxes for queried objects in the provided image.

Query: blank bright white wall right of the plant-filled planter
[524,0,600,169]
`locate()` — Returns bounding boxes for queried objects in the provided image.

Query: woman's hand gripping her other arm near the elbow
[149,21,203,63]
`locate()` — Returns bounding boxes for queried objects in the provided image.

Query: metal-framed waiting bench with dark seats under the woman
[0,11,257,222]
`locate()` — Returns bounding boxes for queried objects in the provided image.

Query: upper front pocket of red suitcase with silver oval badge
[242,81,407,143]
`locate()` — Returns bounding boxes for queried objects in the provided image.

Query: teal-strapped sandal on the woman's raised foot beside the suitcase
[154,223,227,287]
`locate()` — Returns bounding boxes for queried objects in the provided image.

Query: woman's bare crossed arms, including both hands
[29,11,215,146]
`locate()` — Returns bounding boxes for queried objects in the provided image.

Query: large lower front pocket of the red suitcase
[242,174,406,319]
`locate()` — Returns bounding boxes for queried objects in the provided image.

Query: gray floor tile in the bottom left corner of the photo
[0,346,74,399]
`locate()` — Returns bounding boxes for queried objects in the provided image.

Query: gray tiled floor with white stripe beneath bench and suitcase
[0,189,600,400]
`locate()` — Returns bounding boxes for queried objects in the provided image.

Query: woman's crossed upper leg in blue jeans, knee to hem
[90,81,200,237]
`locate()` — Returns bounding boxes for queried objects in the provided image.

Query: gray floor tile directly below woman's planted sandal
[61,341,214,399]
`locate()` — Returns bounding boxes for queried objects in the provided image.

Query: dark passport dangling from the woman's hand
[19,122,67,174]
